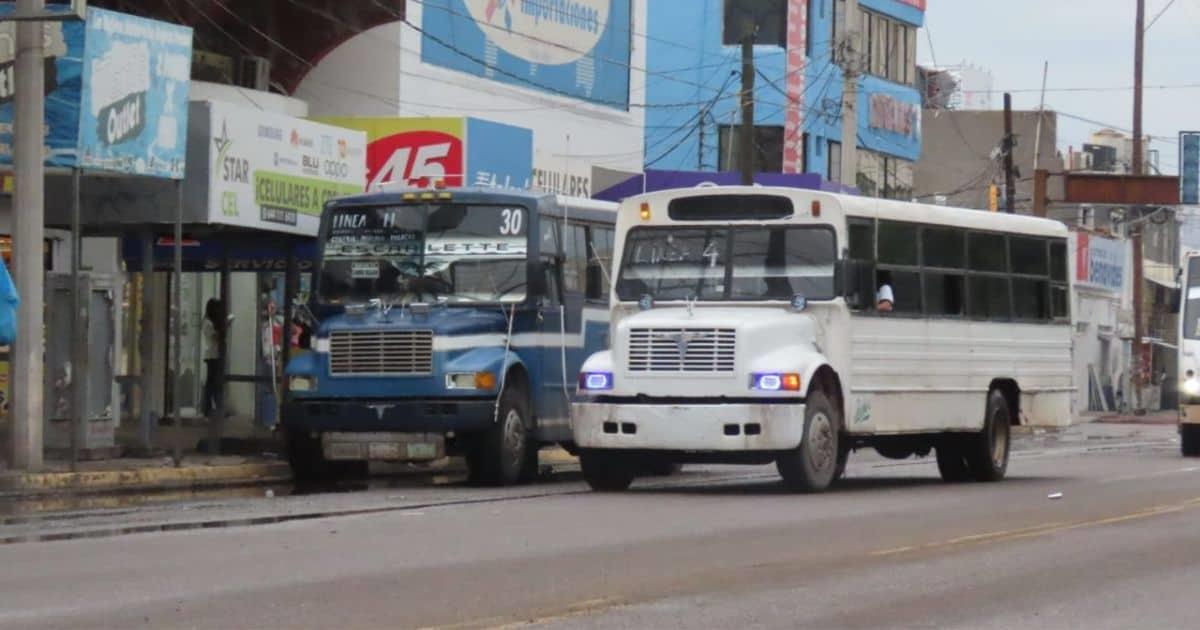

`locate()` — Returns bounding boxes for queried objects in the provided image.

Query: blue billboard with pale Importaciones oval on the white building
[421,0,632,109]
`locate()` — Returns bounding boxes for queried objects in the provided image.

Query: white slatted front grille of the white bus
[629,328,737,373]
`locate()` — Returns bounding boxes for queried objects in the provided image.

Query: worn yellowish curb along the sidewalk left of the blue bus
[0,462,292,494]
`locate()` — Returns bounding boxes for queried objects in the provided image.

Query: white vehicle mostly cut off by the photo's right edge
[1177,252,1200,457]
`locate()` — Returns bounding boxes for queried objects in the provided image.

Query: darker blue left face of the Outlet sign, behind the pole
[0,9,84,168]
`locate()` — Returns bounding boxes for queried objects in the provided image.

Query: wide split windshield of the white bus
[617,226,836,301]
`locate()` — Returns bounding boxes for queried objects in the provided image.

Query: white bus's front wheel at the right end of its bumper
[775,391,841,492]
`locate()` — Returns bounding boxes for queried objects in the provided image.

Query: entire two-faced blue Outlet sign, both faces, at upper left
[0,4,192,179]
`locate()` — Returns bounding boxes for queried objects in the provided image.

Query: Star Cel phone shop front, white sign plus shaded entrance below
[48,101,366,441]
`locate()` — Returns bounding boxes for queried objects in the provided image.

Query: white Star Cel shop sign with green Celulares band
[200,102,366,235]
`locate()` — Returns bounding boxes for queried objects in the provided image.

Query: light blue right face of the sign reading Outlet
[79,8,192,179]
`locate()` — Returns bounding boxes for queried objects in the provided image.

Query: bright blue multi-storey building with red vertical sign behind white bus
[646,0,925,198]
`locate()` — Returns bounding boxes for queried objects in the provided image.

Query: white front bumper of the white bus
[571,402,804,452]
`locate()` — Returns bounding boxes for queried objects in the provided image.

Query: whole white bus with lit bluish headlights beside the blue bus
[572,187,1074,492]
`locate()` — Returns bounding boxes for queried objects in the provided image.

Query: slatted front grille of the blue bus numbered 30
[329,330,433,376]
